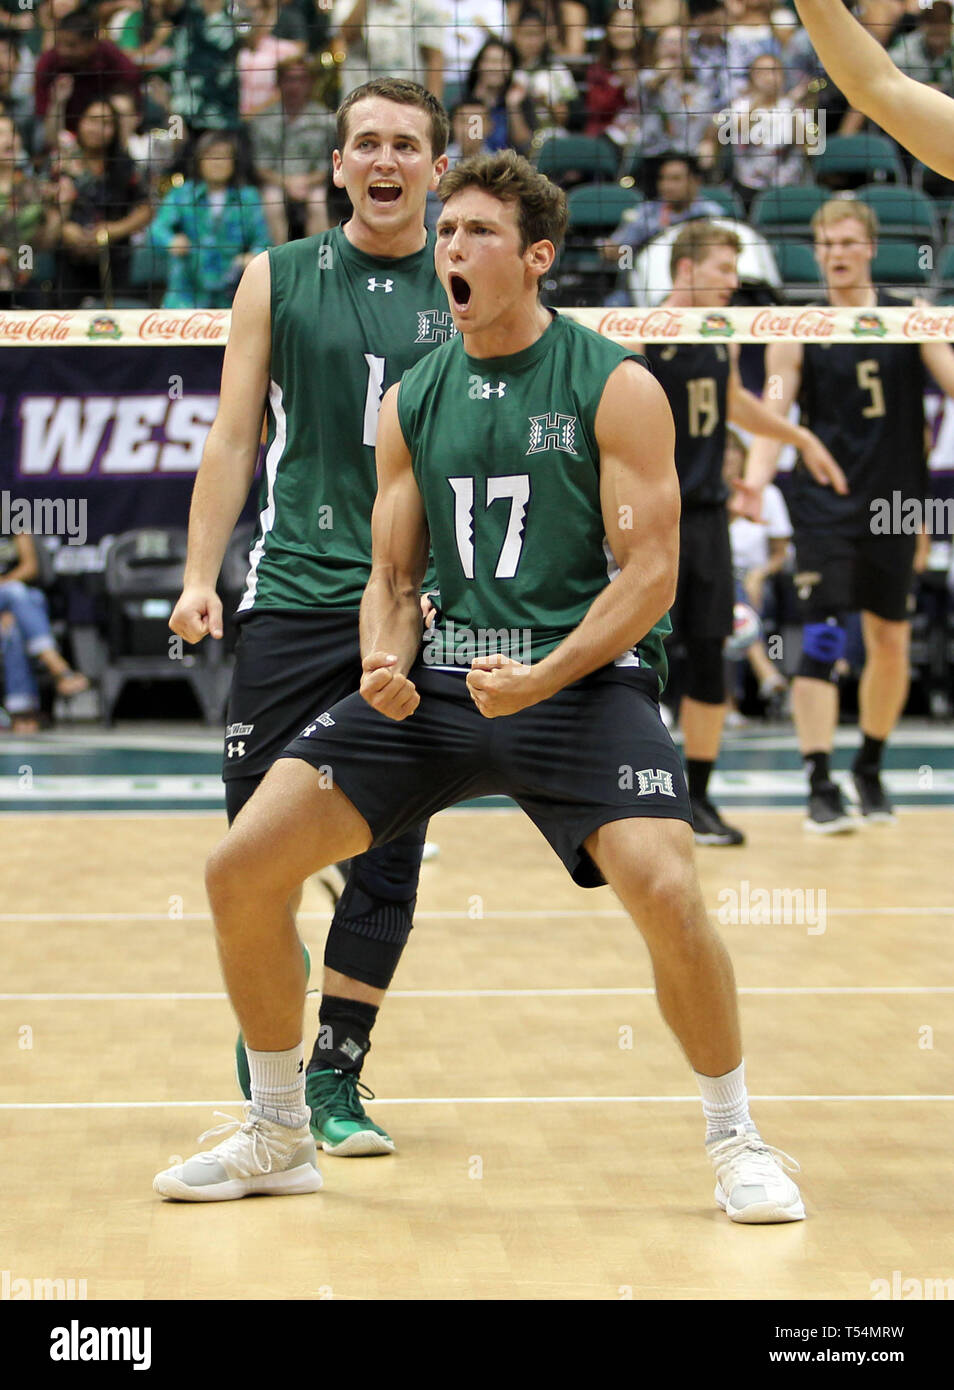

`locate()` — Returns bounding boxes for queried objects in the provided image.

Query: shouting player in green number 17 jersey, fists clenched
[154,152,804,1223]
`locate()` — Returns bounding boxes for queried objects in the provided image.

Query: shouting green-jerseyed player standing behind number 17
[171,79,453,1156]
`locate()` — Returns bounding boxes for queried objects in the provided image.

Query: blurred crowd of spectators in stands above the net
[0,0,954,309]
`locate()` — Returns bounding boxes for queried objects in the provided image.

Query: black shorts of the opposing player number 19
[669,503,736,644]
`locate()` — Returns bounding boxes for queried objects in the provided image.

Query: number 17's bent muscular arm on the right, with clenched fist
[467,361,679,719]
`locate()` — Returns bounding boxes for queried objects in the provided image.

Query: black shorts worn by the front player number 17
[282,662,691,888]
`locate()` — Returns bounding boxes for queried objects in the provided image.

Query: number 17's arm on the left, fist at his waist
[360,386,428,719]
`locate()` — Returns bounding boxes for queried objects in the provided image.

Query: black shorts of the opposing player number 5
[794,531,916,623]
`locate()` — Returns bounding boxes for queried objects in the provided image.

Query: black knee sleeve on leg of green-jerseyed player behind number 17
[324,826,426,990]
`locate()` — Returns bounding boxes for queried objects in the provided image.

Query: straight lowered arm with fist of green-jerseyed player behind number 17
[168,253,271,642]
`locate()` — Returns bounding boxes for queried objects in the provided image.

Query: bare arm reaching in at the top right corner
[795,0,954,178]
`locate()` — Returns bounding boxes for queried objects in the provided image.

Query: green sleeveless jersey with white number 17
[398,317,672,687]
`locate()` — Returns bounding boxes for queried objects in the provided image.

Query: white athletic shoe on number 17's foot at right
[706,1129,805,1225]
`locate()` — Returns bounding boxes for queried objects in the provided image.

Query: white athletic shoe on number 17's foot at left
[153,1105,321,1202]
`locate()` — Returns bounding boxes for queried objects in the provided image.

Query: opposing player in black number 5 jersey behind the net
[747,199,954,834]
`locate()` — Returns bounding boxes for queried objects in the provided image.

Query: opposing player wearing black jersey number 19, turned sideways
[642,221,844,845]
